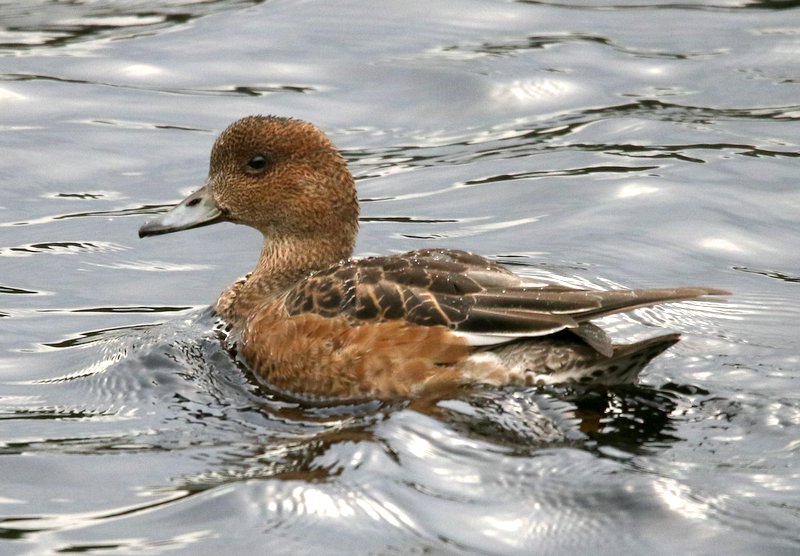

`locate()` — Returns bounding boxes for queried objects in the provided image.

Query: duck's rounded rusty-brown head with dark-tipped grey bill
[139,116,358,256]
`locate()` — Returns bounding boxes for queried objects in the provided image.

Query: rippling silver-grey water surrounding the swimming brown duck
[0,0,800,554]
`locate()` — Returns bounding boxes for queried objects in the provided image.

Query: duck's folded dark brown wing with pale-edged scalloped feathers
[285,249,726,351]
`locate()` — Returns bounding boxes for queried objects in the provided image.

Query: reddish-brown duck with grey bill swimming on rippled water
[139,115,728,400]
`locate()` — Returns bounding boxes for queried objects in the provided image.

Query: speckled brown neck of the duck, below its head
[216,236,353,327]
